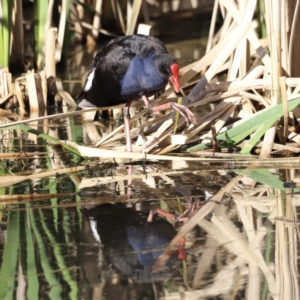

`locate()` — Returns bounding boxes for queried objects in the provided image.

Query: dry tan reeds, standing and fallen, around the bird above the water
[0,0,300,161]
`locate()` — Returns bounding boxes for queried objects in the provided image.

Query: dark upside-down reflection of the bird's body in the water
[84,204,179,283]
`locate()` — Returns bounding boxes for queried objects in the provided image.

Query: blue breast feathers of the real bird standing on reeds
[120,55,167,96]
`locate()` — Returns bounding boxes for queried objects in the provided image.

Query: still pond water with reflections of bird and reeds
[0,140,299,299]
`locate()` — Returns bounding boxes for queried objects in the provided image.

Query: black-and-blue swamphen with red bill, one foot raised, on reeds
[77,35,195,151]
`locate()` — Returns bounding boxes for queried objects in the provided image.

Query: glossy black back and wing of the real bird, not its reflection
[76,35,168,106]
